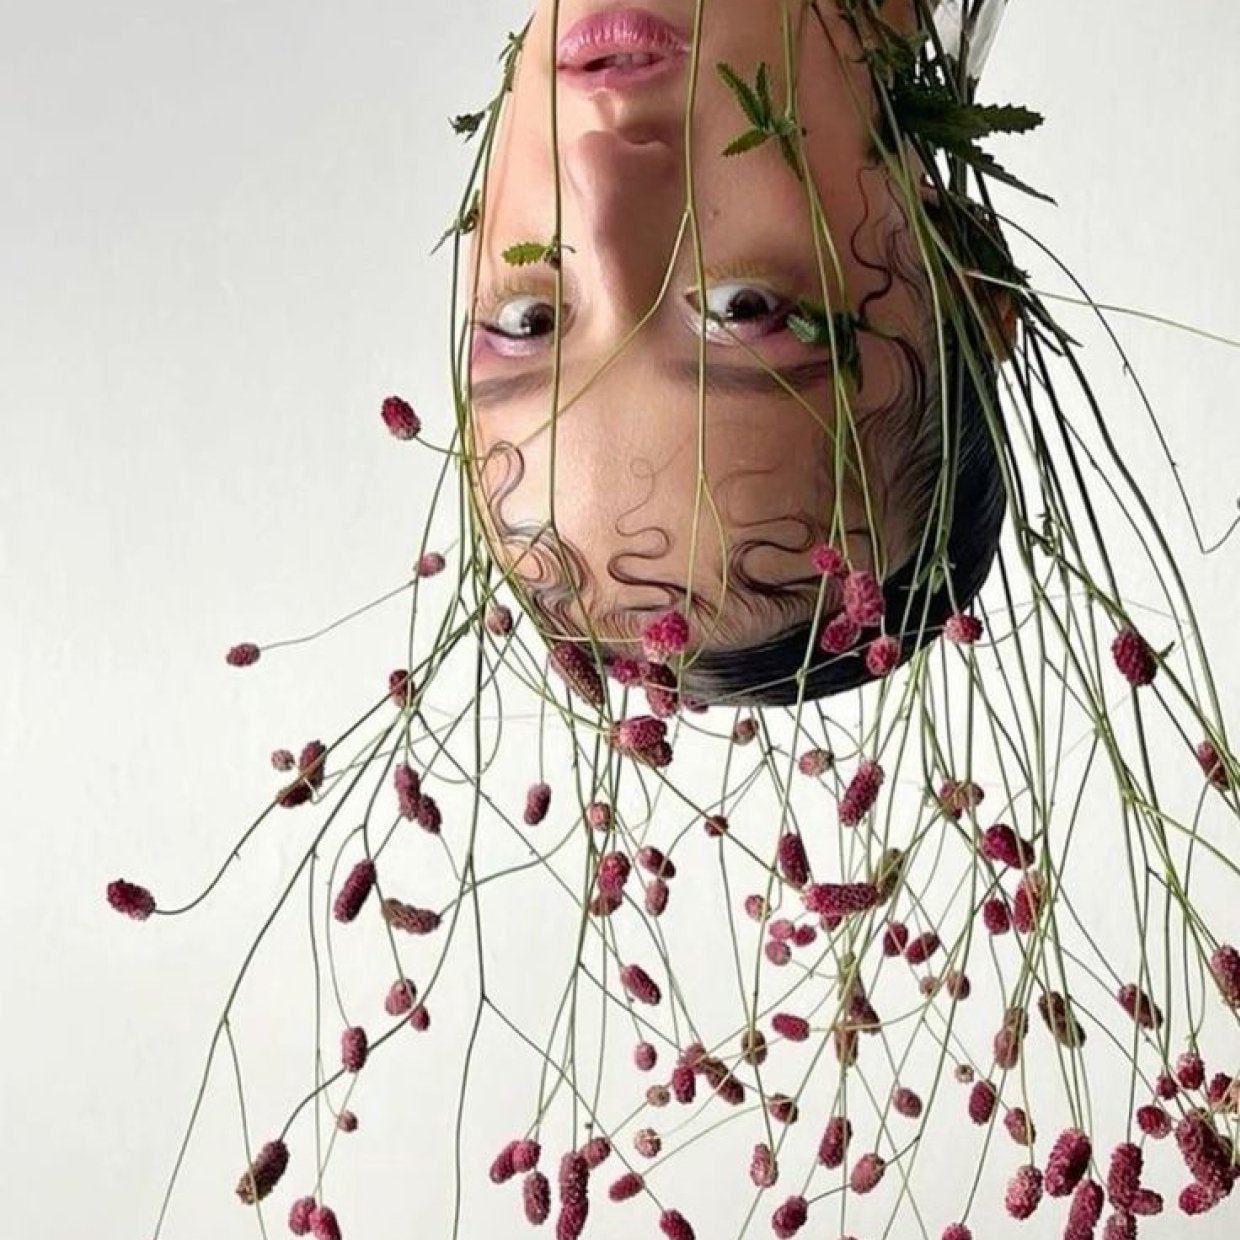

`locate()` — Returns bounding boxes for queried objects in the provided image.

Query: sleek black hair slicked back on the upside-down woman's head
[681,334,1007,706]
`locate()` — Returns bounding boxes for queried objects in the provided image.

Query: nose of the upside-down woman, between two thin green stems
[563,129,684,332]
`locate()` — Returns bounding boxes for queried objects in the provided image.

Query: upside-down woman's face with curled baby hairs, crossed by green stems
[470,0,928,647]
